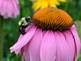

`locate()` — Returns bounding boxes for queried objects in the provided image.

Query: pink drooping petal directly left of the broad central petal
[25,29,42,61]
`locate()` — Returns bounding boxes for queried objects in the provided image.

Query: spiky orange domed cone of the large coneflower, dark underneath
[32,8,73,31]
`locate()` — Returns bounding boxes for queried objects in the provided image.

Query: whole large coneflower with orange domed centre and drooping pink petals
[10,8,80,61]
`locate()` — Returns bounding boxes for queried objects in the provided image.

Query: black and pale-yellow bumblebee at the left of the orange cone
[18,16,31,35]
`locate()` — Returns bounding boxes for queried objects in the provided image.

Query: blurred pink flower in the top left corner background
[0,0,19,18]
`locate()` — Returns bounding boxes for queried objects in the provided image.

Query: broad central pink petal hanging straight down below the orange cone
[40,31,56,61]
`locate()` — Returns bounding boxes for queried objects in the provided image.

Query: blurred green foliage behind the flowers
[0,0,81,61]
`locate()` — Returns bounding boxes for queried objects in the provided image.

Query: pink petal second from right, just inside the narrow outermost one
[63,30,76,61]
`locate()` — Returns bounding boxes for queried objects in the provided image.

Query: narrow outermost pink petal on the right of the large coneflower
[71,25,81,58]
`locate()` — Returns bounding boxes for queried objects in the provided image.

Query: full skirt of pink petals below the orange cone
[10,24,80,61]
